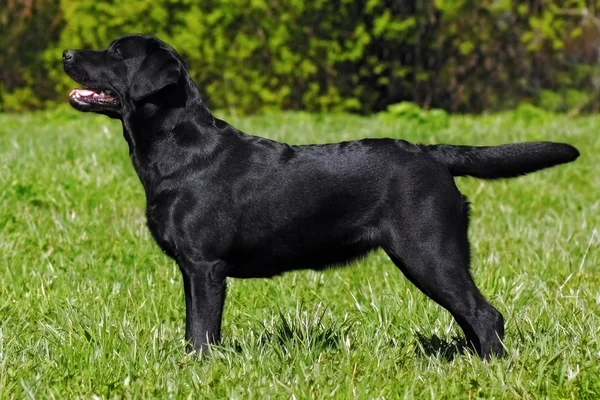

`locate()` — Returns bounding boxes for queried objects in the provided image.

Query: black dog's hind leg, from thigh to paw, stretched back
[382,193,504,359]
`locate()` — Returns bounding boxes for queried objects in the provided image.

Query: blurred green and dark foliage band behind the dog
[0,0,600,113]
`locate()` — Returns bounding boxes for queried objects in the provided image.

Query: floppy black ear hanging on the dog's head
[129,42,182,101]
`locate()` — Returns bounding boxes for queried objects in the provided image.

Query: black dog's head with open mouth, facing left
[63,35,184,119]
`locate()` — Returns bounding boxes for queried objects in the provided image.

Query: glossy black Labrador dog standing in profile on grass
[63,35,579,358]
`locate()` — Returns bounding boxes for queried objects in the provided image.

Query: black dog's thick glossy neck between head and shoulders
[122,74,223,194]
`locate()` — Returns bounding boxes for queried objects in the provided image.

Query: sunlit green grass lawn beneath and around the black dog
[0,110,600,399]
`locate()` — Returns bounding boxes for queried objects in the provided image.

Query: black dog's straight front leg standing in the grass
[180,261,227,354]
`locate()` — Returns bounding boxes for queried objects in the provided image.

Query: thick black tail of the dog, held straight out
[419,142,579,179]
